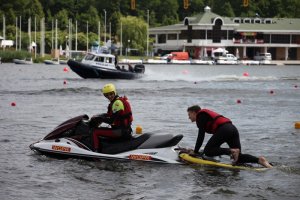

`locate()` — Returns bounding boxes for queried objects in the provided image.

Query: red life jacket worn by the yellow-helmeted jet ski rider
[107,96,133,128]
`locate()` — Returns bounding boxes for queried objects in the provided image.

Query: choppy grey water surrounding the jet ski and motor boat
[0,64,300,200]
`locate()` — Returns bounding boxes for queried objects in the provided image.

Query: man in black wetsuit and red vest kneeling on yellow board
[187,105,272,168]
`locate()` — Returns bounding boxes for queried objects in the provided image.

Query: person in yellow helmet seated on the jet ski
[91,83,133,152]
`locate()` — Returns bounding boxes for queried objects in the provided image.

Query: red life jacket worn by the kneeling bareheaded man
[197,109,231,134]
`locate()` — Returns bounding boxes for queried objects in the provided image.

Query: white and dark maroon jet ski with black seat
[30,115,183,164]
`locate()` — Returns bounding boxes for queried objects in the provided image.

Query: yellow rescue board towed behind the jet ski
[179,153,268,171]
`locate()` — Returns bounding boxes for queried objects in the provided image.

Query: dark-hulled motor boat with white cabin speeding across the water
[67,52,145,79]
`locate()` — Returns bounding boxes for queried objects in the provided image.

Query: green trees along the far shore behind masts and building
[0,0,300,54]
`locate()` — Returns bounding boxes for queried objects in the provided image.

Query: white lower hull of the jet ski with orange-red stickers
[30,138,181,164]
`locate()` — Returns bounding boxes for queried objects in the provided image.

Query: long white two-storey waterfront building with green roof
[149,7,300,60]
